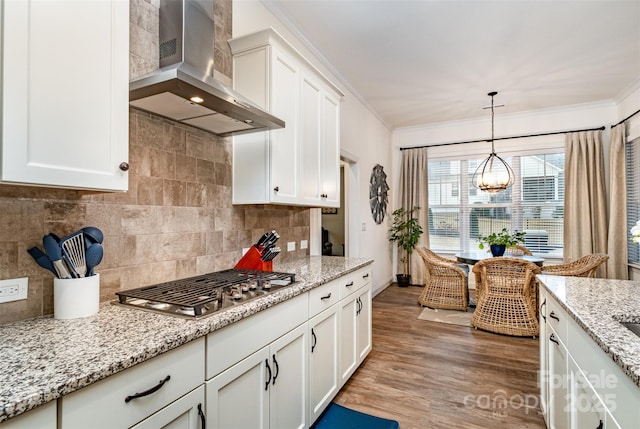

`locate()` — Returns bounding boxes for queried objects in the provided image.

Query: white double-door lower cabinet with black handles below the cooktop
[206,324,309,429]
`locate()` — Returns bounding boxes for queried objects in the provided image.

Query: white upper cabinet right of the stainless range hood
[229,29,343,207]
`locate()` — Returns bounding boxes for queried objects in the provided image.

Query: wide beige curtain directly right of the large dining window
[564,131,608,278]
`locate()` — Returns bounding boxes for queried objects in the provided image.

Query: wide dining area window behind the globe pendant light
[428,149,564,258]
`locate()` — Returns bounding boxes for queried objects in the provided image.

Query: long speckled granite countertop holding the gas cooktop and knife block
[0,256,373,422]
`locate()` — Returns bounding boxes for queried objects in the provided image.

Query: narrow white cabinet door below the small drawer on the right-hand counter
[547,328,570,429]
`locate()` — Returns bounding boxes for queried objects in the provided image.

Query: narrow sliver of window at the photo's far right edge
[625,138,640,263]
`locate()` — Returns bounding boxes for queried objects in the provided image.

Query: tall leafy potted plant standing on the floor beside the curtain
[389,207,423,287]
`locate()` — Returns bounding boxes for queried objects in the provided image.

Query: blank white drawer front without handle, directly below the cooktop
[207,293,309,380]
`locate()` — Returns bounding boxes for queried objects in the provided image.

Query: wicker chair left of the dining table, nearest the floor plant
[416,247,469,311]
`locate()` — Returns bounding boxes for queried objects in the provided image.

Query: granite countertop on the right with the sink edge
[537,274,640,387]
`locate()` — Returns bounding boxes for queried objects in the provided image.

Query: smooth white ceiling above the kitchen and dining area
[264,0,640,129]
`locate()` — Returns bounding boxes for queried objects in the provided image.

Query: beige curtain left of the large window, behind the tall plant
[398,147,429,285]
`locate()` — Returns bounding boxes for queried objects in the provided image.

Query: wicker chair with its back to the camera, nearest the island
[471,257,540,337]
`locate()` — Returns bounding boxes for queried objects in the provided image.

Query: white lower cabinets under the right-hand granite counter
[539,288,640,429]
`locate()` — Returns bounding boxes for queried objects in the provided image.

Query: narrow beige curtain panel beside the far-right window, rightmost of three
[607,124,629,280]
